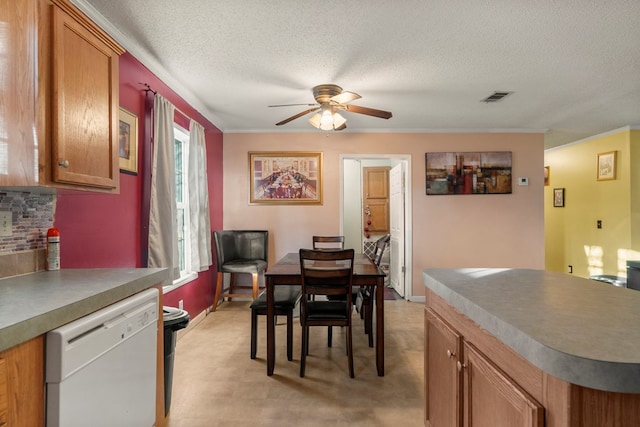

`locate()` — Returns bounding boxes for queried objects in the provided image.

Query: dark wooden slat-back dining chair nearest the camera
[300,249,354,378]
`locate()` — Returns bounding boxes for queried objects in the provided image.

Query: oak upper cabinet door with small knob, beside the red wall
[51,2,119,189]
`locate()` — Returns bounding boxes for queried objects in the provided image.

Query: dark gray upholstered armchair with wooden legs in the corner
[213,230,269,311]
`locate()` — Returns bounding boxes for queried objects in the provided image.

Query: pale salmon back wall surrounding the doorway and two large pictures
[223,132,544,295]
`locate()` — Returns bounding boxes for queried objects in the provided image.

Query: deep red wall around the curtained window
[54,53,222,317]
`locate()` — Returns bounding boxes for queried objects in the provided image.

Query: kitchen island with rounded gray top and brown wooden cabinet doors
[423,268,640,427]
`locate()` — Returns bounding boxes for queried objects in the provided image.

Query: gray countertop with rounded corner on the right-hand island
[423,268,640,393]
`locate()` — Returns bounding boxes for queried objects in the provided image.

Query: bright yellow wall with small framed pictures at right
[544,129,640,277]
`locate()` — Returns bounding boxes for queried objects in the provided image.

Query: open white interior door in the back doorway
[389,162,405,297]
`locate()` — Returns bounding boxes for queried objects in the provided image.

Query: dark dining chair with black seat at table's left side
[249,285,302,361]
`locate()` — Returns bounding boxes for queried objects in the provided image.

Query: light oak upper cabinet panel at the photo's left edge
[0,0,38,186]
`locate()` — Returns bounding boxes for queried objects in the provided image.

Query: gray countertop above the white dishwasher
[0,268,167,351]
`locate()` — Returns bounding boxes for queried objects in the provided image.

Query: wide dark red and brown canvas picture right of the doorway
[425,151,511,196]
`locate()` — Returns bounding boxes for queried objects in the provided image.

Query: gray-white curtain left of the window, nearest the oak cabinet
[148,94,180,282]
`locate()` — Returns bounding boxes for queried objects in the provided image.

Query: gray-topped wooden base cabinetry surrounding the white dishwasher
[0,268,167,426]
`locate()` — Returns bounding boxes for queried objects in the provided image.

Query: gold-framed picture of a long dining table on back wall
[249,151,322,205]
